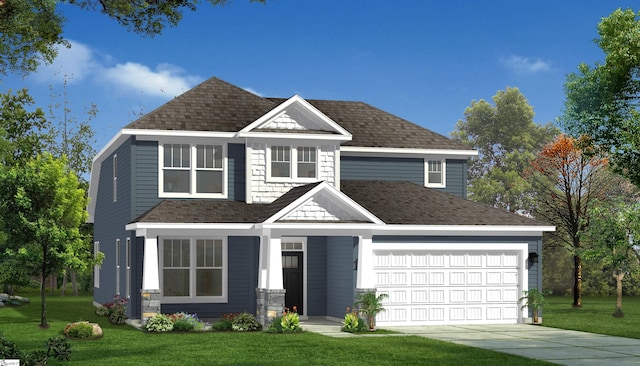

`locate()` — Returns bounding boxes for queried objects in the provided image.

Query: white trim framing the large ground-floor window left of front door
[158,234,229,304]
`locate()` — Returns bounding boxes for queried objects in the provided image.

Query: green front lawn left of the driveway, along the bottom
[0,296,548,365]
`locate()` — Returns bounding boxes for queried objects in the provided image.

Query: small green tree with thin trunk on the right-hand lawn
[584,200,640,317]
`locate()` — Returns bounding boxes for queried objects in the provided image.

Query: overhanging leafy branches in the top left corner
[0,0,266,74]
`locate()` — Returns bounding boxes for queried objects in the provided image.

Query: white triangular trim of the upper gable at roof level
[238,94,352,141]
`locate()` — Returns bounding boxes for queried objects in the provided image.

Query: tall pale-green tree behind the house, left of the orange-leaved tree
[451,88,557,212]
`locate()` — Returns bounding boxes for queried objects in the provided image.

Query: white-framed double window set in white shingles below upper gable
[267,145,318,182]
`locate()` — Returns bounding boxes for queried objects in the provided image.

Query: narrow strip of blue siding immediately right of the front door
[305,236,328,316]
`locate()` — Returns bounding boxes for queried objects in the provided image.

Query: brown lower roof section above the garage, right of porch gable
[340,180,546,226]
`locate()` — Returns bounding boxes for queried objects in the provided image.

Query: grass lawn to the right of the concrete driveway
[542,296,640,339]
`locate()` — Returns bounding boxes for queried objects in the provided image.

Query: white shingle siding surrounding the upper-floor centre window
[249,143,336,203]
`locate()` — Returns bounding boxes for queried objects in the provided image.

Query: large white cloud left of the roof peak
[29,41,202,98]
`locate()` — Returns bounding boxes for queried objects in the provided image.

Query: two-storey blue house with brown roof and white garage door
[89,78,554,325]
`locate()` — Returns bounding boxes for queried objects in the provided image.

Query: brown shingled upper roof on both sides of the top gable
[125,78,469,150]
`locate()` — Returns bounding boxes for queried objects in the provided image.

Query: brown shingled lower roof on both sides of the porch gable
[134,180,546,226]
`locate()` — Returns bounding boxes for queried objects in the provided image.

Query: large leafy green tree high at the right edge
[561,9,640,187]
